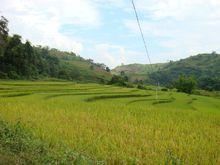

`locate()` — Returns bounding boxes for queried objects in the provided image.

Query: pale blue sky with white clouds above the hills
[0,0,220,68]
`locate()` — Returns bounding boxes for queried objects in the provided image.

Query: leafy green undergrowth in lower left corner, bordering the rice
[0,119,96,164]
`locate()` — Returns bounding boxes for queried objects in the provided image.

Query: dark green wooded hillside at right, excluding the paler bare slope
[150,52,220,90]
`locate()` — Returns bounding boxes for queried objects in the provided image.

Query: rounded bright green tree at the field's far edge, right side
[174,75,196,94]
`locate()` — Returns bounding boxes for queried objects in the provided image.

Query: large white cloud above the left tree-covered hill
[1,0,100,53]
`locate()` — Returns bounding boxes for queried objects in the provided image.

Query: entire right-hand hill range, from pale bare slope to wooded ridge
[114,52,220,90]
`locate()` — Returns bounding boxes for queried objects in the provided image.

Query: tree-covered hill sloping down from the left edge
[0,17,111,82]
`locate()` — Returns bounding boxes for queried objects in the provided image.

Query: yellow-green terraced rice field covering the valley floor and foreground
[0,81,220,164]
